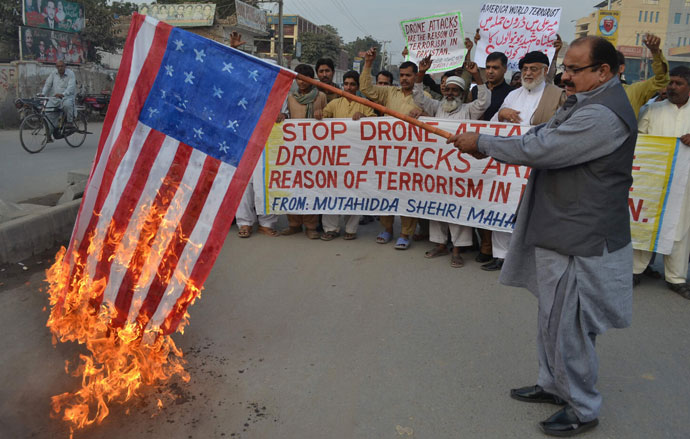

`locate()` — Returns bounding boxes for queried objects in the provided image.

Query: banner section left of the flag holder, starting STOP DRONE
[254,117,529,231]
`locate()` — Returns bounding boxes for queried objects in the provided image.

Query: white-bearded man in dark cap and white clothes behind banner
[481,51,566,271]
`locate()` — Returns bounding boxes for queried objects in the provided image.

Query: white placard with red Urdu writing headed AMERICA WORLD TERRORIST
[474,3,561,70]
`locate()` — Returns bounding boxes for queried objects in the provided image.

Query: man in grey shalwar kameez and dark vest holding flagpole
[449,37,637,436]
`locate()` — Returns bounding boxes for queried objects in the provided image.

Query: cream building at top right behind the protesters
[575,0,690,82]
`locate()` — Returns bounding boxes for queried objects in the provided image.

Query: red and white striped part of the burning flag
[59,14,294,334]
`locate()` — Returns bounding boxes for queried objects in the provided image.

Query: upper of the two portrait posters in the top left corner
[22,0,85,32]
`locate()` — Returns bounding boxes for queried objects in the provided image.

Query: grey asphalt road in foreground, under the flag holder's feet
[0,220,690,439]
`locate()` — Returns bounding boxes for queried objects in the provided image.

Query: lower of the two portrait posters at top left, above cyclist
[19,26,87,64]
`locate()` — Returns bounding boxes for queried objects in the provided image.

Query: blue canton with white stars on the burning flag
[139,28,279,167]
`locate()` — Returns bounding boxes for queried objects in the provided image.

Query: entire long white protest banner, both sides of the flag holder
[253,118,690,254]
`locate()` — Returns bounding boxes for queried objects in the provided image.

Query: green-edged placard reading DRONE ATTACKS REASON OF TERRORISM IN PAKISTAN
[400,12,467,73]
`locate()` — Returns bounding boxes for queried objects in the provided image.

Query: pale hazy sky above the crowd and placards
[276,0,599,64]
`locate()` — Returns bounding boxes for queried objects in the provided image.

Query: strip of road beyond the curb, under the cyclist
[0,122,103,203]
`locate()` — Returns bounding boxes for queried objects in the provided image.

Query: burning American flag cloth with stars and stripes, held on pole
[60,14,295,334]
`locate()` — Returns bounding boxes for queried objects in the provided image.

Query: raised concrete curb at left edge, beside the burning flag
[0,198,81,264]
